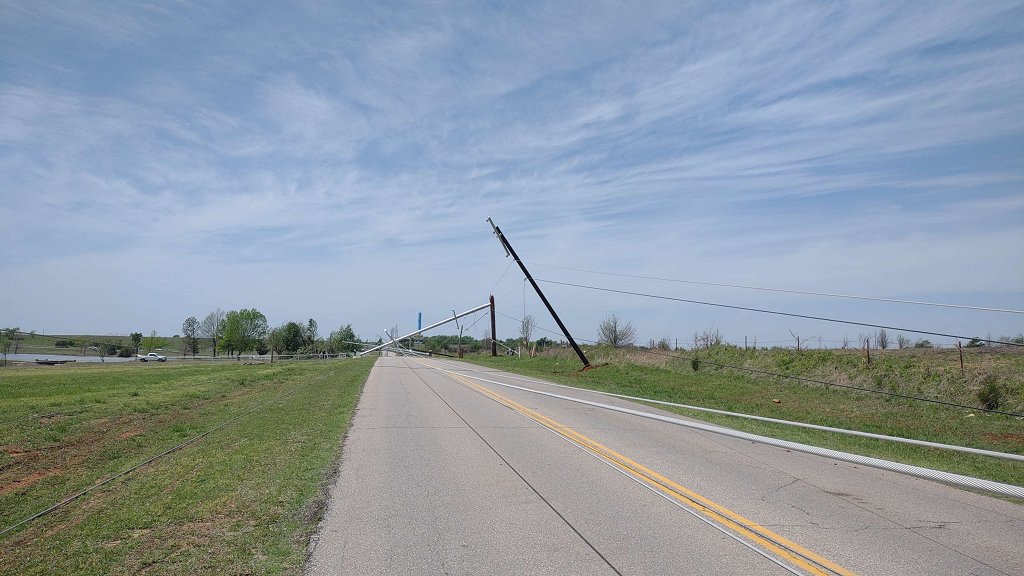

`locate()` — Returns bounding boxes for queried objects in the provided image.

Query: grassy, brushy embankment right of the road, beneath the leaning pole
[467,346,1024,486]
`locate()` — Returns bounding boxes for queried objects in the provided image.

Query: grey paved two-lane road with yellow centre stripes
[307,358,1024,575]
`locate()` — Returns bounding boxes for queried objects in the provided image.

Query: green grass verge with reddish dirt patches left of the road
[0,359,373,574]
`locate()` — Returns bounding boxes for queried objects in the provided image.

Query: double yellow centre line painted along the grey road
[424,364,854,576]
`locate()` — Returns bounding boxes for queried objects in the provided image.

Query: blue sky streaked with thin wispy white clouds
[0,0,1024,343]
